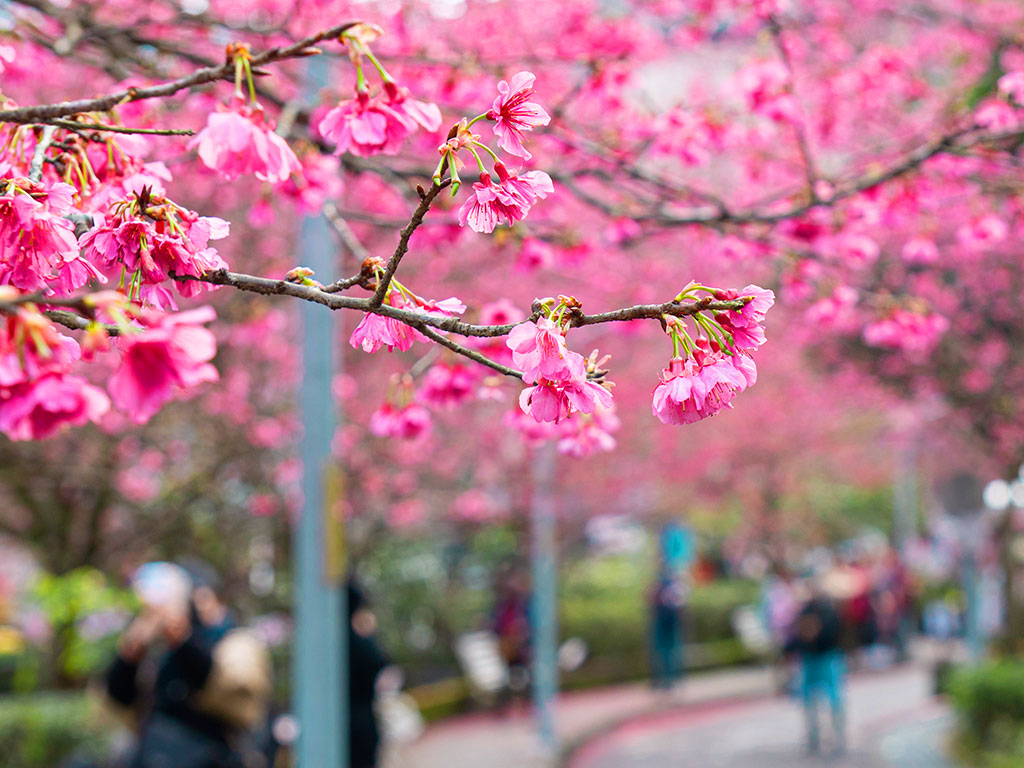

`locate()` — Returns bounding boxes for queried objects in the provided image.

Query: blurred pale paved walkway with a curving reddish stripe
[397,667,948,768]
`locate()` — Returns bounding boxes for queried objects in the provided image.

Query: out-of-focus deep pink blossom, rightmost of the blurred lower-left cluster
[110,307,218,424]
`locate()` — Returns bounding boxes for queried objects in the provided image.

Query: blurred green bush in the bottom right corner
[949,658,1024,768]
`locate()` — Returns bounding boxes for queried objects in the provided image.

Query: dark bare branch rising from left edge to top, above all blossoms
[0,22,358,124]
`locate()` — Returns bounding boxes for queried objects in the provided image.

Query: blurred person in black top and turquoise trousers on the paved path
[786,578,846,753]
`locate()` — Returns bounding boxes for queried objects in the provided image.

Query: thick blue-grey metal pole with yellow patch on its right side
[292,56,348,768]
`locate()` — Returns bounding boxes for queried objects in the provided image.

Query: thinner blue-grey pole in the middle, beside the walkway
[530,443,558,755]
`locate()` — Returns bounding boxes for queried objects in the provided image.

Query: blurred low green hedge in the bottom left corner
[0,692,110,768]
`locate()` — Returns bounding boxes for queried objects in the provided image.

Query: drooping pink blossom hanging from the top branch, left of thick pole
[188,101,302,184]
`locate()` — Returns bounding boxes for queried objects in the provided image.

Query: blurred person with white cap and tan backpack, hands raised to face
[105,560,274,768]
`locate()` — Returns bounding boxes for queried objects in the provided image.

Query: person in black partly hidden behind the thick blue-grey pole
[348,581,390,768]
